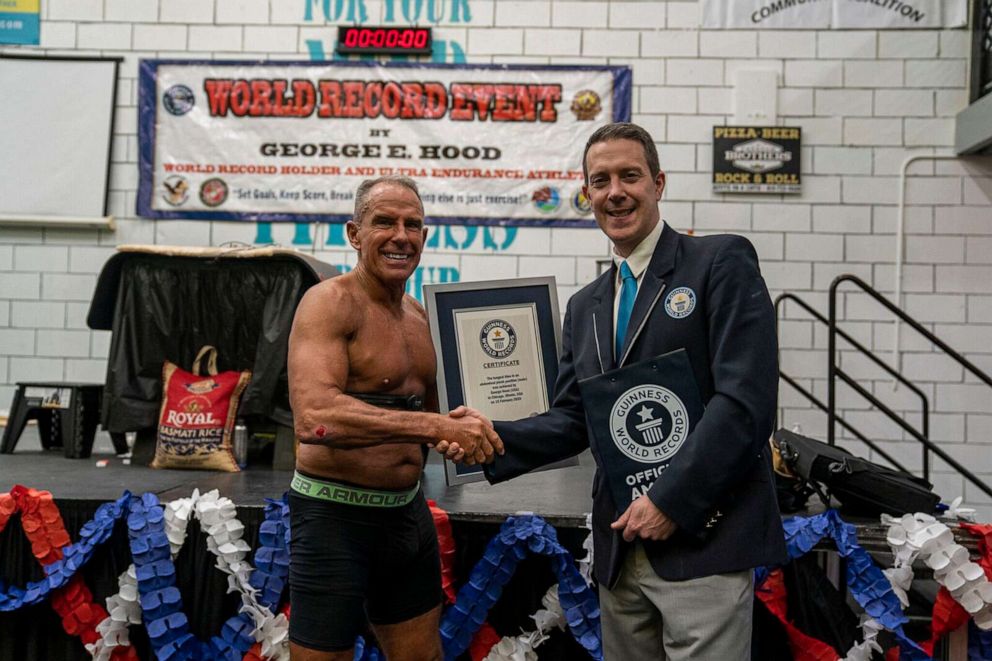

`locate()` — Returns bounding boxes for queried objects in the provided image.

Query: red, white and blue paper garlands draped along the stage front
[0,486,992,661]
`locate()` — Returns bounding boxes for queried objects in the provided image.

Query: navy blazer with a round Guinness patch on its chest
[485,225,786,586]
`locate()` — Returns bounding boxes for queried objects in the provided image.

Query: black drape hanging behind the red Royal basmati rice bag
[101,255,312,432]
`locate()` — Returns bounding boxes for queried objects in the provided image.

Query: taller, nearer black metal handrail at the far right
[827,273,992,496]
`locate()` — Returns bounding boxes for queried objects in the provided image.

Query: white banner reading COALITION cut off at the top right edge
[702,0,968,30]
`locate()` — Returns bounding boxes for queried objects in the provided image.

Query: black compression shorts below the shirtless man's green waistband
[289,482,442,652]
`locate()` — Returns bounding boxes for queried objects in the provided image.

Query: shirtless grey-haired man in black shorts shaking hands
[289,177,502,661]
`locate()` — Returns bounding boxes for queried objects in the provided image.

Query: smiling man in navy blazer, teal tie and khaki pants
[438,124,786,661]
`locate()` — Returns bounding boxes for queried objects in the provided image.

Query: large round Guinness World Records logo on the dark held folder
[610,384,689,464]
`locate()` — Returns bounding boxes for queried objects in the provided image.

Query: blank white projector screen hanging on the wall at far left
[0,55,119,221]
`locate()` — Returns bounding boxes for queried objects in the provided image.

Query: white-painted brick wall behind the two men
[0,0,992,512]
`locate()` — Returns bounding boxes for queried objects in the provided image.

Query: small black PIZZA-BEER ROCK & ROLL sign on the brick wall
[713,126,802,193]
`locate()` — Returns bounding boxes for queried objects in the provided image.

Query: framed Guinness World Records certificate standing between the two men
[424,277,575,485]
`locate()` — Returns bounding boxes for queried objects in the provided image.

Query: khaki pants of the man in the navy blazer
[599,543,754,661]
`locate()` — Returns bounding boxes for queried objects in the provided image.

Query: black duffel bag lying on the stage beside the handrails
[772,429,940,516]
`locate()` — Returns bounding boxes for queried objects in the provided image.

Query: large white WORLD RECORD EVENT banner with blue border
[138,60,631,226]
